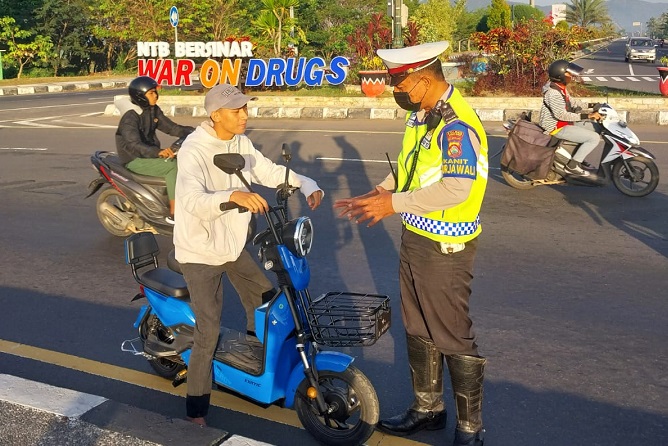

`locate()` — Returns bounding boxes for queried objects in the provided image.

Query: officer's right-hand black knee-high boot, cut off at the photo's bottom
[446,355,486,446]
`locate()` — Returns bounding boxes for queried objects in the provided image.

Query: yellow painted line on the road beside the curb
[0,339,425,446]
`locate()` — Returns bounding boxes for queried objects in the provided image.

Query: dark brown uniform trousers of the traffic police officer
[399,230,478,356]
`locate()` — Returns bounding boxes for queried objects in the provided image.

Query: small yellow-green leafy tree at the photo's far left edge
[0,17,53,78]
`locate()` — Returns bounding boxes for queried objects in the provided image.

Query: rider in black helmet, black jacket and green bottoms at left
[116,76,195,224]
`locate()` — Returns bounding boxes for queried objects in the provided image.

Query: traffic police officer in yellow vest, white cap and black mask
[334,42,488,446]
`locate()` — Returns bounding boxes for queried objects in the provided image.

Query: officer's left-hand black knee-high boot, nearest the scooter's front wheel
[378,335,446,436]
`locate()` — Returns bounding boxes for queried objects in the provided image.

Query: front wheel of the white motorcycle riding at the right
[612,156,659,197]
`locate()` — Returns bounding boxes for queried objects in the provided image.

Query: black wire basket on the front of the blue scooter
[306,291,391,347]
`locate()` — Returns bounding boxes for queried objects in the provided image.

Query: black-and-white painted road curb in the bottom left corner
[0,374,271,446]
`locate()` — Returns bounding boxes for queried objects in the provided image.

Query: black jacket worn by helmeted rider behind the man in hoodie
[116,105,195,164]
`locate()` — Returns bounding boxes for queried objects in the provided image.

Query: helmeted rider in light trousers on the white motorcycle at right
[539,59,601,177]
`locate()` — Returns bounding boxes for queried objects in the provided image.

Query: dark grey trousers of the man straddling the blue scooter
[181,250,273,417]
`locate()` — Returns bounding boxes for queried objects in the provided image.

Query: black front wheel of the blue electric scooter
[295,366,380,446]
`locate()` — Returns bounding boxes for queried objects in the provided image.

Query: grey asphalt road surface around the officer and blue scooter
[0,92,668,446]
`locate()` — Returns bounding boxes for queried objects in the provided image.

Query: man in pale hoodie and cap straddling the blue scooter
[174,84,324,426]
